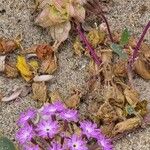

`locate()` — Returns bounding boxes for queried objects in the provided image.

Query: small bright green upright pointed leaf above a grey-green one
[120,28,130,46]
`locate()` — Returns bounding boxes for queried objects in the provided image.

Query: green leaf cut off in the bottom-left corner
[0,137,16,150]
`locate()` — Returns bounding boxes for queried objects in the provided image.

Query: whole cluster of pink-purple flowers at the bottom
[16,101,113,150]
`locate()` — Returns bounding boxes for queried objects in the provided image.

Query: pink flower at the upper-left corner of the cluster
[17,108,36,126]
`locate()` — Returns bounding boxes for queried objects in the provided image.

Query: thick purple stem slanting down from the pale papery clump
[77,24,102,65]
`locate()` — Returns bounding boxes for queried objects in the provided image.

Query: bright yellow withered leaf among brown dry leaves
[16,56,33,81]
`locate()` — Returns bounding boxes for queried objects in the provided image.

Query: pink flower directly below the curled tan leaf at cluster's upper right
[60,109,78,122]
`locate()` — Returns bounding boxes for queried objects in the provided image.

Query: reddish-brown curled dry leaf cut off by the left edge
[0,38,18,55]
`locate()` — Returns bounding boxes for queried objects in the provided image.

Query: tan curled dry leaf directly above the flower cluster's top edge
[65,91,81,108]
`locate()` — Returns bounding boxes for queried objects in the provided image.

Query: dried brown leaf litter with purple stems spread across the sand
[0,0,150,148]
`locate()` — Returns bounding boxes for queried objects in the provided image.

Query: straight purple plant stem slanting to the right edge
[131,21,150,65]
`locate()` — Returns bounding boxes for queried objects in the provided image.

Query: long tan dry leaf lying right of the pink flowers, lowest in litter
[112,117,141,135]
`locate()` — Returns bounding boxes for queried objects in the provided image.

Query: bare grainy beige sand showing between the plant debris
[0,0,150,150]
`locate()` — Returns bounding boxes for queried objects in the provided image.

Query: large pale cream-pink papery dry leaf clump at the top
[35,0,85,45]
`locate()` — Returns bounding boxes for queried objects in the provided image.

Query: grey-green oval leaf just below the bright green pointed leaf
[110,44,128,59]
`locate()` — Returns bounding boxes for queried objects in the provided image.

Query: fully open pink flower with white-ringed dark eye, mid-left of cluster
[36,120,59,138]
